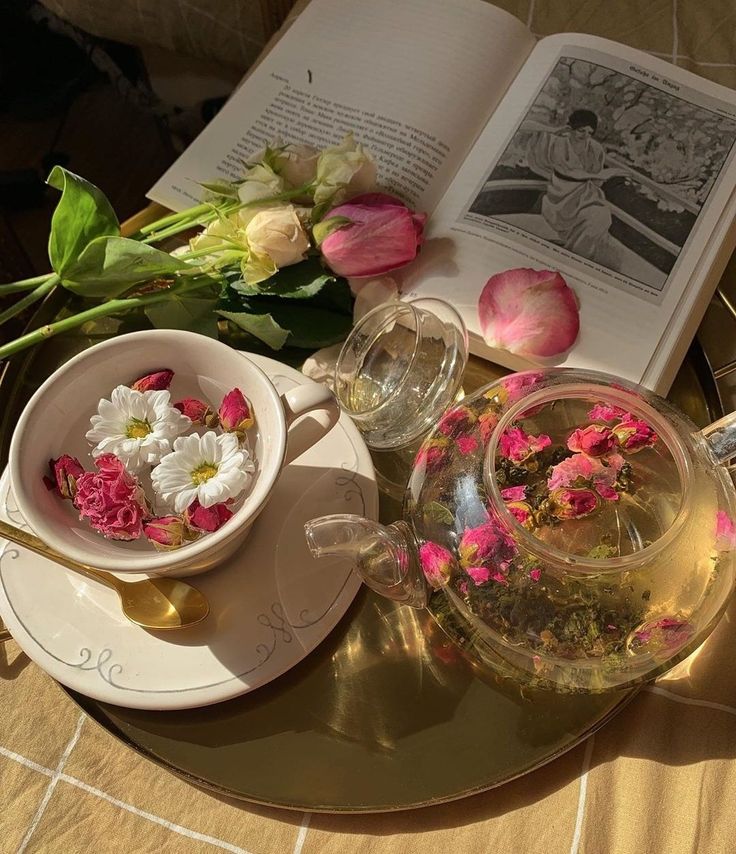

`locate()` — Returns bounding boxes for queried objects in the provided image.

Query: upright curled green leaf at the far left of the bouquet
[47,166,120,279]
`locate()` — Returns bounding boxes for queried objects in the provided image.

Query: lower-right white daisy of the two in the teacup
[151,432,255,513]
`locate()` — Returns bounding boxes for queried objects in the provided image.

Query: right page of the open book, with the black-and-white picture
[405,34,736,390]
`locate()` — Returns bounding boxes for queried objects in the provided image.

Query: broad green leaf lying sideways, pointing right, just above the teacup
[62,237,192,297]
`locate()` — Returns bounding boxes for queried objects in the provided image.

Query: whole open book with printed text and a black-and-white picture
[149,0,736,393]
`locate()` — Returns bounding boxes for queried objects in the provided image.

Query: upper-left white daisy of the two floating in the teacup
[86,385,192,473]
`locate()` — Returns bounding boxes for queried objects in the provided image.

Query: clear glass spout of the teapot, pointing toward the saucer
[304,514,427,608]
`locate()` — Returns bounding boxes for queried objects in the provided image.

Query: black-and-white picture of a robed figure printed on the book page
[465,57,736,292]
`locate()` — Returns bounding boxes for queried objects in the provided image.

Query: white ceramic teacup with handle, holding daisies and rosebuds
[9,330,340,576]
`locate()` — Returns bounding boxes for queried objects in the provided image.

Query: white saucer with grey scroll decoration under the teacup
[0,355,378,709]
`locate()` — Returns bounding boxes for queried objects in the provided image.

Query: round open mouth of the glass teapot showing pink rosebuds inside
[483,382,692,572]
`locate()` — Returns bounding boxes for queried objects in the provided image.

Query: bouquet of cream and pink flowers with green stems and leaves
[0,135,426,359]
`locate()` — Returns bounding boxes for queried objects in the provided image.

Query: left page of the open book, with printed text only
[148,0,534,216]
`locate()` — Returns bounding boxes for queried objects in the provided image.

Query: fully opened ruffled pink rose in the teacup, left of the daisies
[74,454,149,540]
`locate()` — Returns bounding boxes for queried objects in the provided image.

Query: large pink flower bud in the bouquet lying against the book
[315,193,427,278]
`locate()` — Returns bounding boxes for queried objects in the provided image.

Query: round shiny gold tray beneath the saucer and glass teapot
[0,209,728,812]
